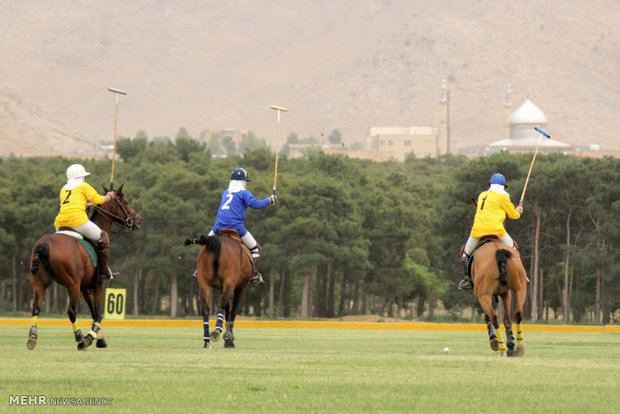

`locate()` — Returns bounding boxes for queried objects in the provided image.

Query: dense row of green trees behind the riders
[0,137,620,324]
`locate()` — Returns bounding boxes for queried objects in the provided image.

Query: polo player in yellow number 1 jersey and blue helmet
[459,173,523,290]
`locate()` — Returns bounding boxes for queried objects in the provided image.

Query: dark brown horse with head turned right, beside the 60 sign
[27,185,142,350]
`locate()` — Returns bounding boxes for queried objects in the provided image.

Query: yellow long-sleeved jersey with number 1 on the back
[471,191,521,238]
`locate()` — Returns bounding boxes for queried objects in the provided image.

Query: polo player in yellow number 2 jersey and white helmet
[54,164,115,279]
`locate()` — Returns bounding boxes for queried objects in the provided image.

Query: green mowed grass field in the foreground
[0,322,620,414]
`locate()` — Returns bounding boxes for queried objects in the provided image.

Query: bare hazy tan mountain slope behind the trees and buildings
[0,0,620,155]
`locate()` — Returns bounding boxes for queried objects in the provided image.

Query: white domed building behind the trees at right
[488,99,572,152]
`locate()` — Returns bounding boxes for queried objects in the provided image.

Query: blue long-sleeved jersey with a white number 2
[213,190,271,237]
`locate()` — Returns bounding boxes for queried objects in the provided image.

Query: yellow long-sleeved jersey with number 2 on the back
[54,182,105,227]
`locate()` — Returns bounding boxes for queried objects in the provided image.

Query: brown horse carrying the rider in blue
[185,229,252,349]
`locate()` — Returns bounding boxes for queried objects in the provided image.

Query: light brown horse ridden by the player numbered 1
[464,236,527,357]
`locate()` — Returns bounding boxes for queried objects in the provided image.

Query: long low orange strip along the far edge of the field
[0,317,620,333]
